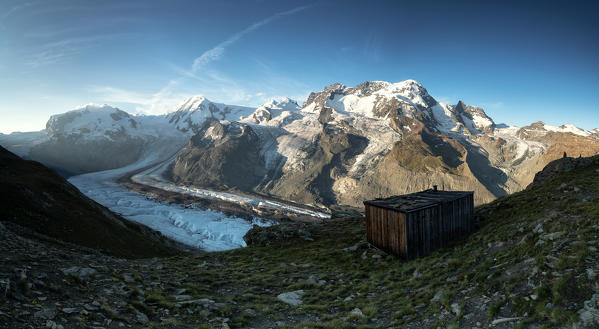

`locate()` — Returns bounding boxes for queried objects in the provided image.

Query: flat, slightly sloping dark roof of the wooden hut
[364,190,474,213]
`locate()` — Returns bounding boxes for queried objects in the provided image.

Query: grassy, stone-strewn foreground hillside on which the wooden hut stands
[0,157,599,328]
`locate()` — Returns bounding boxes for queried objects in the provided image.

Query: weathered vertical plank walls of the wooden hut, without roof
[365,194,474,259]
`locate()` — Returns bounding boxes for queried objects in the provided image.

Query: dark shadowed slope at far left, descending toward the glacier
[0,147,178,258]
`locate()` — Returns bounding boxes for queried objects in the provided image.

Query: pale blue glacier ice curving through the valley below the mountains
[69,143,272,251]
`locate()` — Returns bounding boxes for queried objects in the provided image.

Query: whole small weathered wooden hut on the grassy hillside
[364,186,474,259]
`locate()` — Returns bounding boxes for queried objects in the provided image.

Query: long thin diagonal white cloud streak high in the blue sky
[191,5,311,73]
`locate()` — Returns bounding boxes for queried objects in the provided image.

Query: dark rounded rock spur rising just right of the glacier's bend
[171,120,267,191]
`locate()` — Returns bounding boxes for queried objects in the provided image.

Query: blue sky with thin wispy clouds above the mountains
[0,0,599,133]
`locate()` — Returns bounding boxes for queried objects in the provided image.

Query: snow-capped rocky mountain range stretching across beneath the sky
[0,80,599,207]
